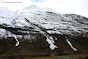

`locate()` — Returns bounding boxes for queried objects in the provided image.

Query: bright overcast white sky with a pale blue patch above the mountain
[0,0,88,17]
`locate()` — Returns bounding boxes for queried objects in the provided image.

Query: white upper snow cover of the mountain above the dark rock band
[0,6,88,36]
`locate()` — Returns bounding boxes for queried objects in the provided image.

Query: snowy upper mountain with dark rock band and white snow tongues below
[0,5,88,54]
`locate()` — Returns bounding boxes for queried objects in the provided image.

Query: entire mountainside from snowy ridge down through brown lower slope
[0,6,88,54]
